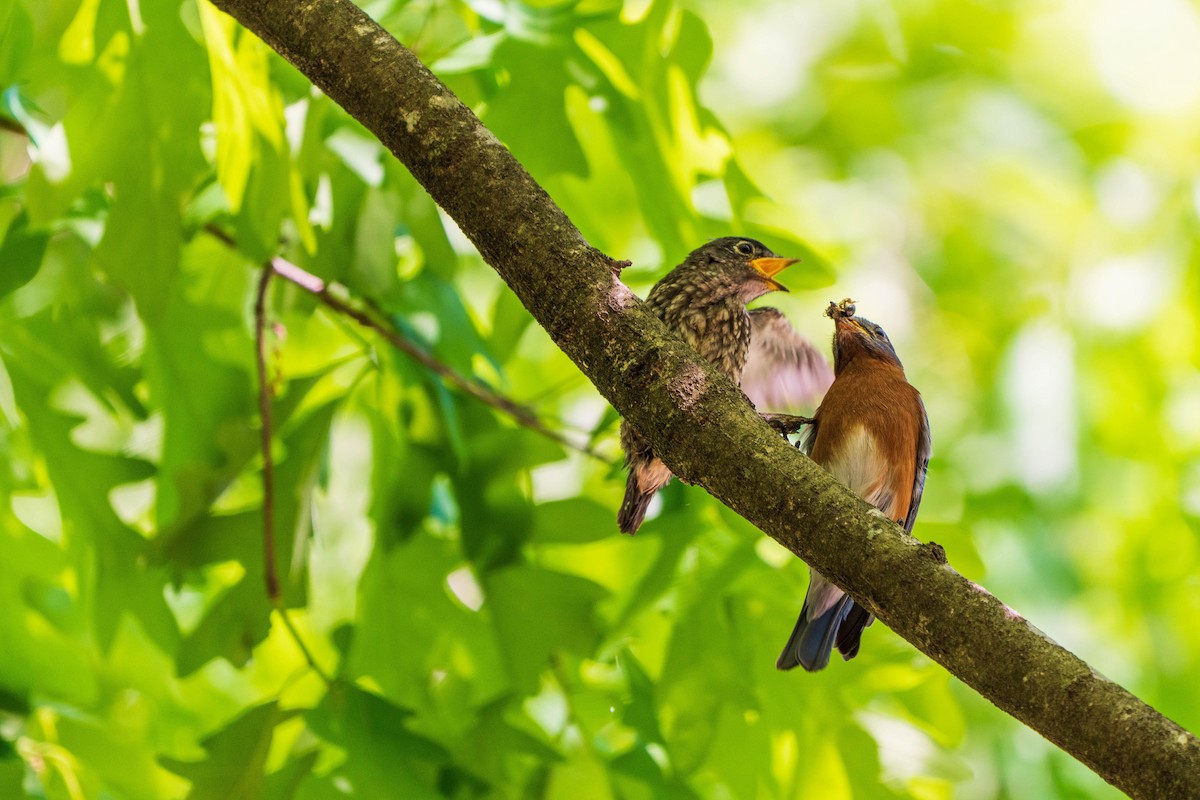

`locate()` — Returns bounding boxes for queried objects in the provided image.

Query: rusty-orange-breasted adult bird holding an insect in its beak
[775,300,931,672]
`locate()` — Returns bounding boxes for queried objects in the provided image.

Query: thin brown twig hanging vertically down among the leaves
[254,264,332,684]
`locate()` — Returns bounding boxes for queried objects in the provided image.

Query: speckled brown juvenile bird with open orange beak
[617,236,833,534]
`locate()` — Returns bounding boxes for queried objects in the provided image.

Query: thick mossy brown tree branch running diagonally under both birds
[214,0,1200,798]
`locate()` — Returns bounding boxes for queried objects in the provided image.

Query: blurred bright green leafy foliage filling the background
[0,0,1200,800]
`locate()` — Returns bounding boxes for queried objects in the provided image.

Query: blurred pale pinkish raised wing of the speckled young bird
[742,308,833,411]
